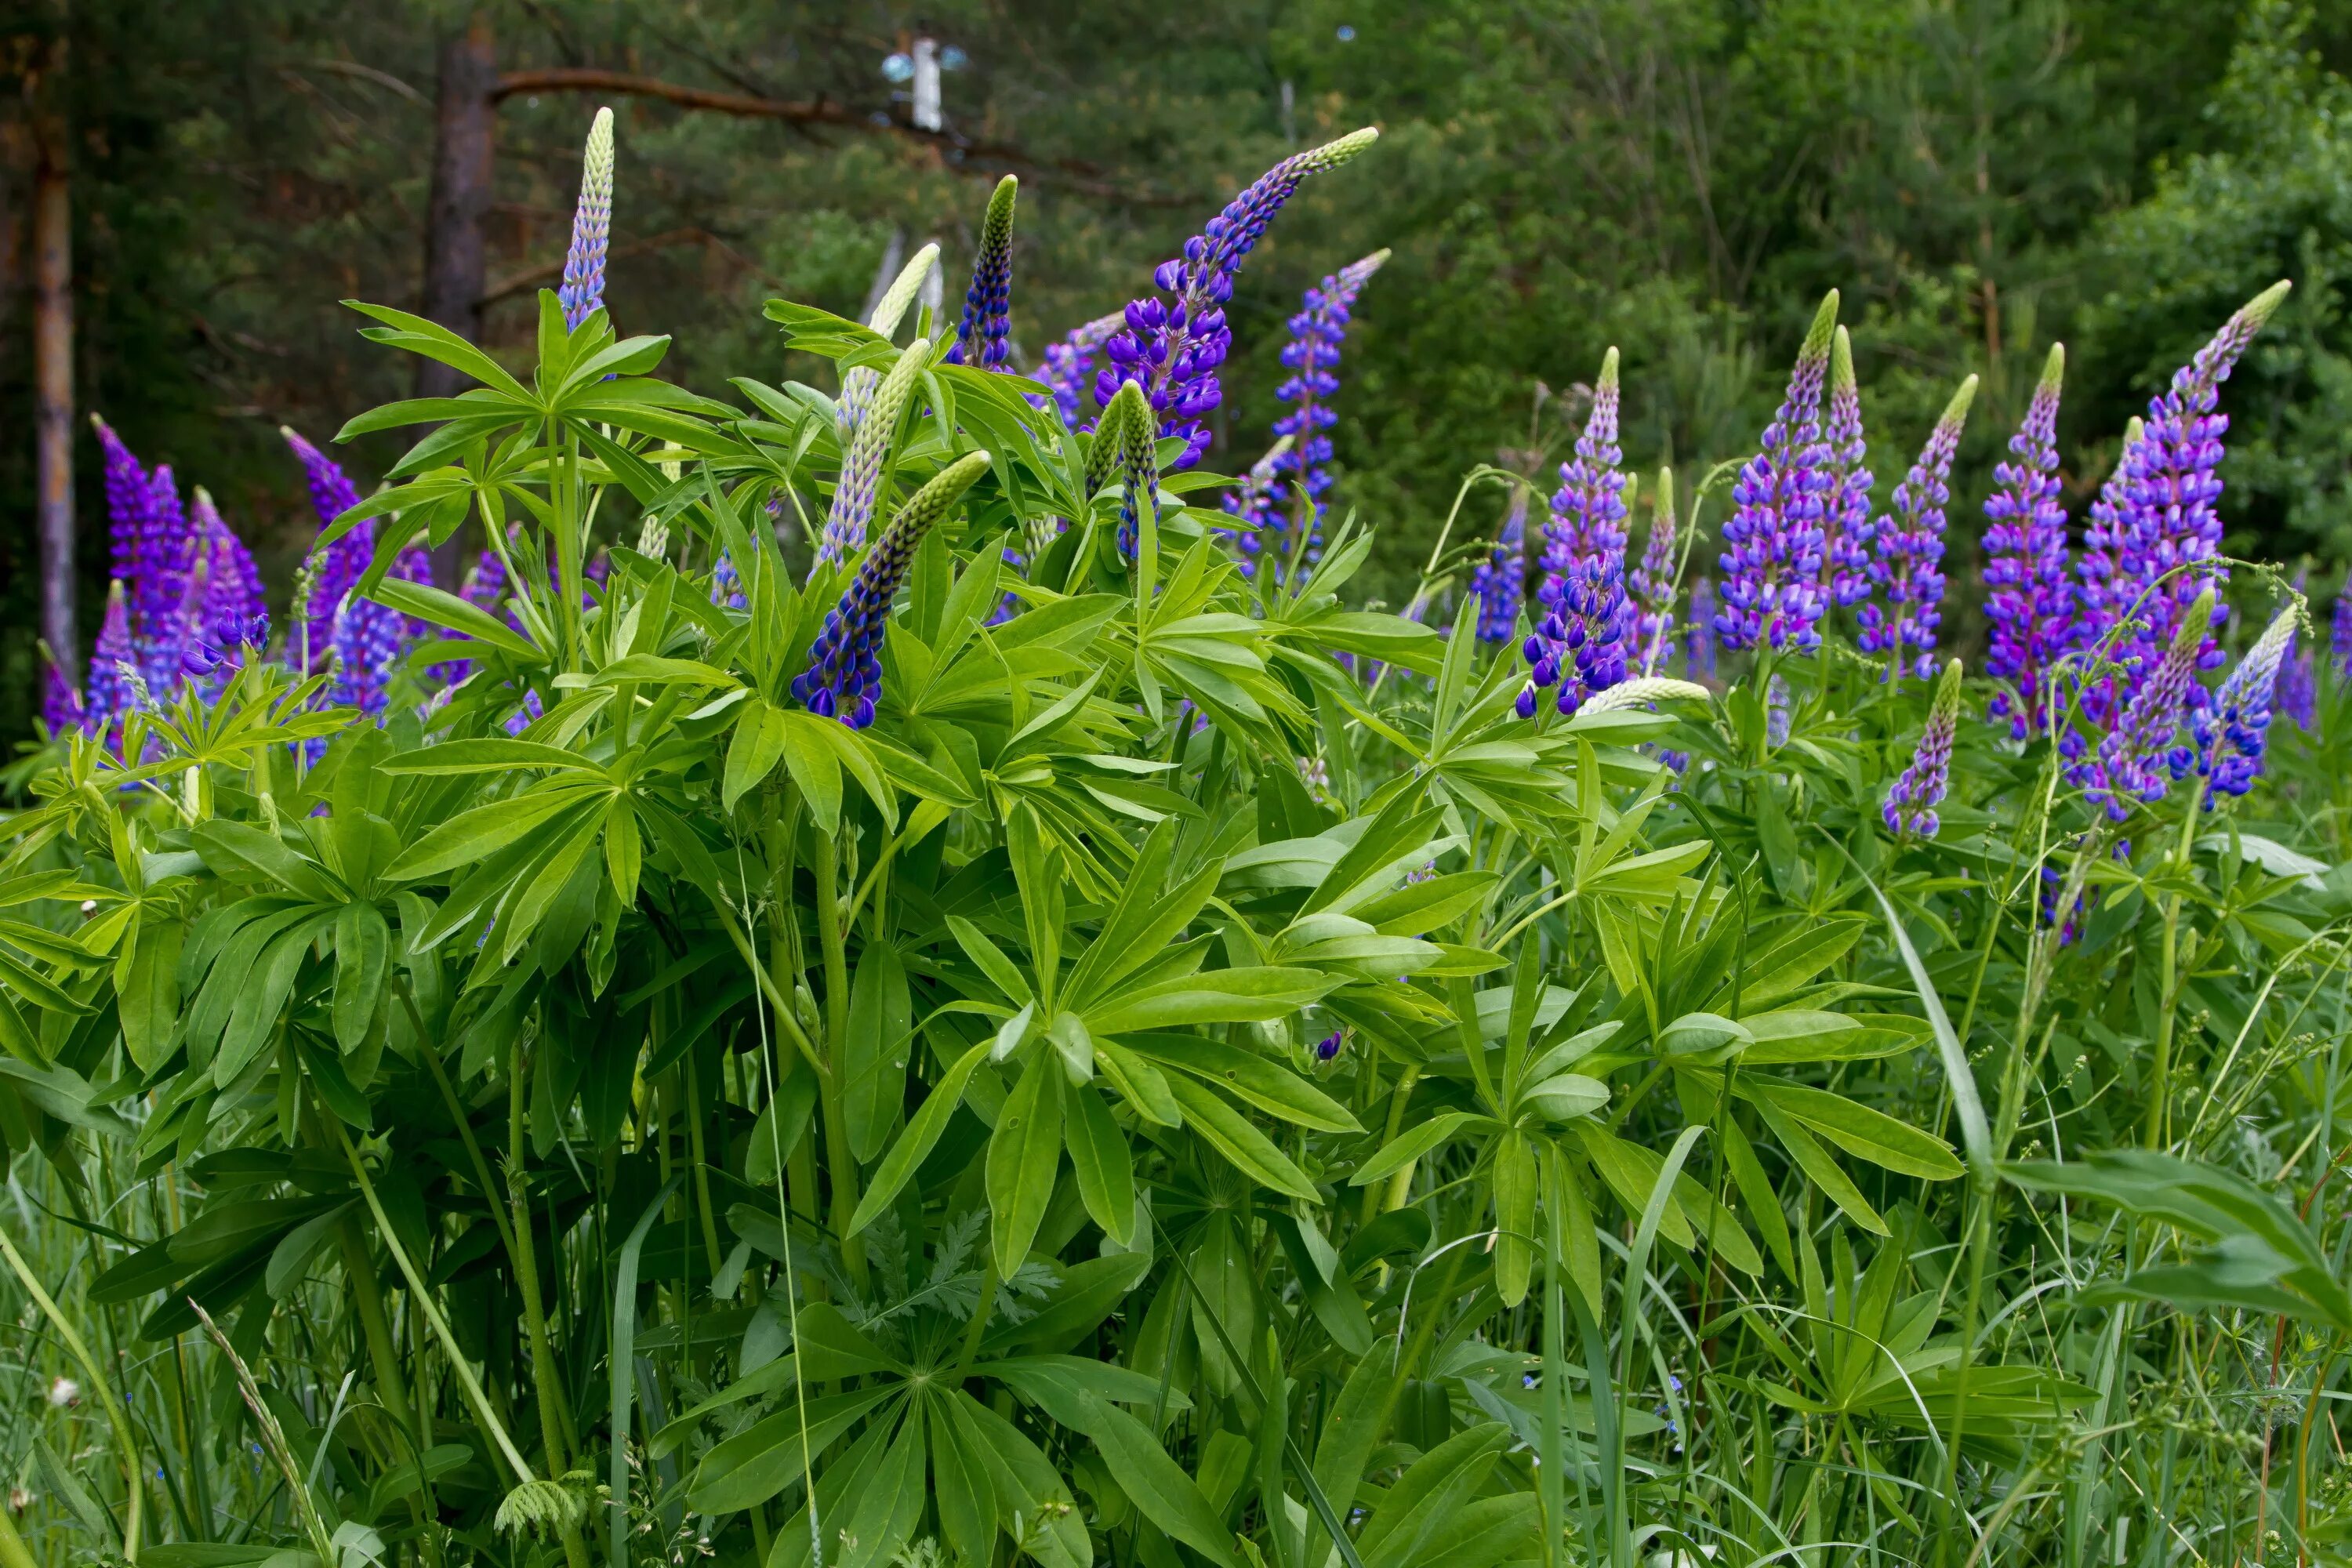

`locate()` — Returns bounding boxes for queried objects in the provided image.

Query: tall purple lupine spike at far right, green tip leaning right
[2086,282,2291,686]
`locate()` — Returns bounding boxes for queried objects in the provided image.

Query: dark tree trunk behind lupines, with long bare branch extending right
[416,12,499,588]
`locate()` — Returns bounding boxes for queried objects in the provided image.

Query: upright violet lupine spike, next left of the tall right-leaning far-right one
[1985,343,2074,741]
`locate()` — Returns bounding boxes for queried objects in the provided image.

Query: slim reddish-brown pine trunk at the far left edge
[33,60,80,682]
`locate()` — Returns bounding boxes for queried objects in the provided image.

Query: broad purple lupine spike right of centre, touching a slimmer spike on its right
[1715,289,1837,652]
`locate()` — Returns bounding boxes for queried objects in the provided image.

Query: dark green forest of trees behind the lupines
[0,0,2352,746]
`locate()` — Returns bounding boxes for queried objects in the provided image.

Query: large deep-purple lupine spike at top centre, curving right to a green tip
[1094,129,1381,468]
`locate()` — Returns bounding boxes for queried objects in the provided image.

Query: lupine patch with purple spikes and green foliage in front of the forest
[0,115,2352,1568]
